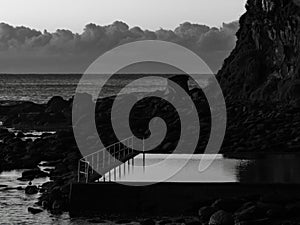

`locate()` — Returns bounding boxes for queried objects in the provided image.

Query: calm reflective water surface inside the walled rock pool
[106,154,300,184]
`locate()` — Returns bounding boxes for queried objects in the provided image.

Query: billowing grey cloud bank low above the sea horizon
[0,21,239,73]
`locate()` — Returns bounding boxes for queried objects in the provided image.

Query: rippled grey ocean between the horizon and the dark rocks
[0,74,207,103]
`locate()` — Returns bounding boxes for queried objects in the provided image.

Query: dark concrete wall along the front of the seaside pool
[70,183,300,216]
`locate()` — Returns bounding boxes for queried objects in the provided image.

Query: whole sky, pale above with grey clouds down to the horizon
[0,0,245,73]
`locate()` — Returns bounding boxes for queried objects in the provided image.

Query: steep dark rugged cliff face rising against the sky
[218,0,300,105]
